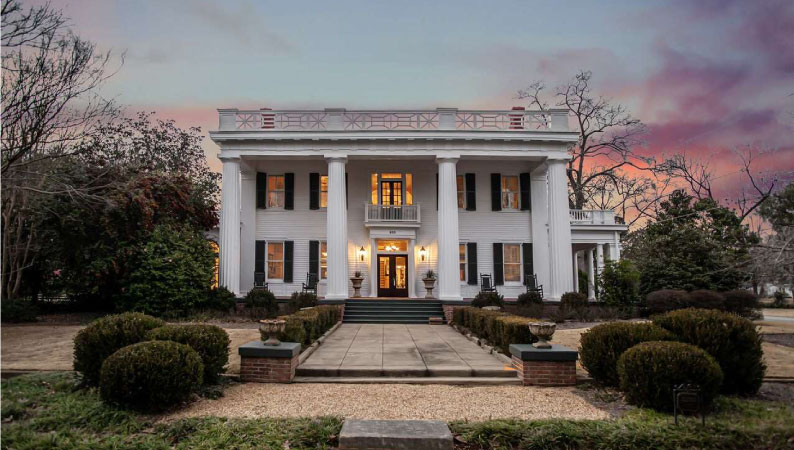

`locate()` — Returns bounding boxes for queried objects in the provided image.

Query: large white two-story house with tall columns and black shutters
[210,108,626,301]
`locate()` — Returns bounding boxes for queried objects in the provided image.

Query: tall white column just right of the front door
[436,157,462,300]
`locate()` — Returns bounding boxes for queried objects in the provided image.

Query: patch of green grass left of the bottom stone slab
[0,372,342,450]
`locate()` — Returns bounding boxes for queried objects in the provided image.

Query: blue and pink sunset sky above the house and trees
[38,0,794,199]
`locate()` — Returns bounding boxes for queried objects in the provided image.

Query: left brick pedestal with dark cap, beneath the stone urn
[238,341,301,383]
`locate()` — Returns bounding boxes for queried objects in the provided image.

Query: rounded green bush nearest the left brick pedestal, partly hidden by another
[147,324,231,383]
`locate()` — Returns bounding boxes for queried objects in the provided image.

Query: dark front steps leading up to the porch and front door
[342,299,446,324]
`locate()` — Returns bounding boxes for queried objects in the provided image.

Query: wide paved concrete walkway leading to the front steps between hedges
[298,323,515,377]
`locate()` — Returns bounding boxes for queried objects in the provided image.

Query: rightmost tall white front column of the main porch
[547,159,573,299]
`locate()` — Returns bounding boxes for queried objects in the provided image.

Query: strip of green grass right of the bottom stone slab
[450,397,794,450]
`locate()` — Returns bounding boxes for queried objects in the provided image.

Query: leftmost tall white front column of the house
[218,156,240,295]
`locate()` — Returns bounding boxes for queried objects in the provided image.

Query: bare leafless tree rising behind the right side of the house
[518,71,653,209]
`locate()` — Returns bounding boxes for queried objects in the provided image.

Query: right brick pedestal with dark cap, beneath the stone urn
[510,344,578,386]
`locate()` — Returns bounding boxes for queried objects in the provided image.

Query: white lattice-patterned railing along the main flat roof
[218,108,568,132]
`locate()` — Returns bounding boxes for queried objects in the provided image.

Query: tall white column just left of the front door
[325,156,348,300]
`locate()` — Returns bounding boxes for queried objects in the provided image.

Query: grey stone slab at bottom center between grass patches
[339,420,453,450]
